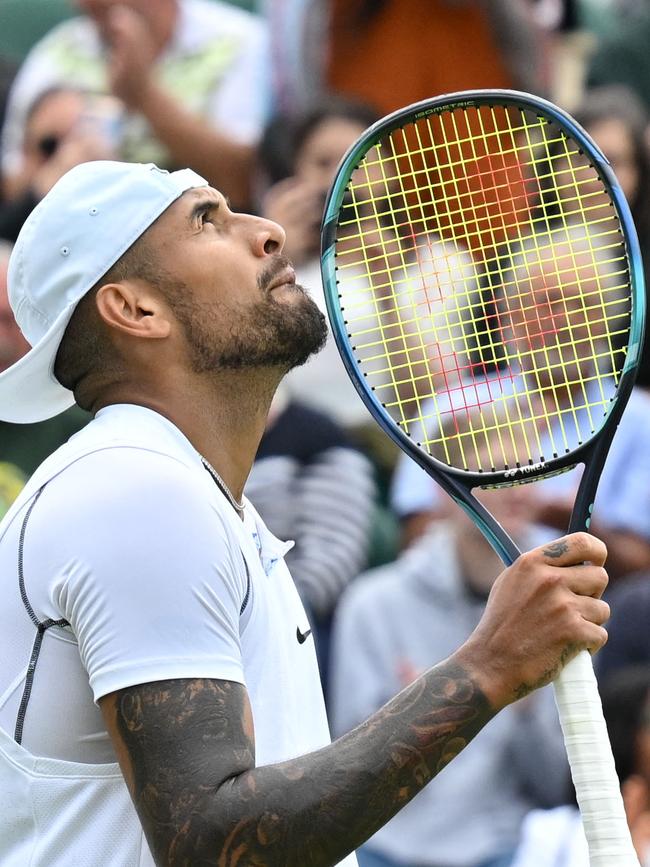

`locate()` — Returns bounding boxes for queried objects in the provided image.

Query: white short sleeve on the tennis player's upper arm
[30,448,247,700]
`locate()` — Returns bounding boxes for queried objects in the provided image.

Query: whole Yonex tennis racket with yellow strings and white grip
[321,90,644,867]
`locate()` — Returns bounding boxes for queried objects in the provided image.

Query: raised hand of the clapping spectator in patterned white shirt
[106,6,158,109]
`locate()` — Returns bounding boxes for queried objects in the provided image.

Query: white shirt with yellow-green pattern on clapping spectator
[2,0,270,175]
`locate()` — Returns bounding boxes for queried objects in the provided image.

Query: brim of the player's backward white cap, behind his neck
[0,305,74,424]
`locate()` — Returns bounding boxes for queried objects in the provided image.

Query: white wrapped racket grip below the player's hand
[553,650,639,867]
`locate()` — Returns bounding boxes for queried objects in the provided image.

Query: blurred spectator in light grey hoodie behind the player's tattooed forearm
[330,474,567,867]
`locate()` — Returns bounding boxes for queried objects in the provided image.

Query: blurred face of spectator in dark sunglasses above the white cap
[23,90,85,169]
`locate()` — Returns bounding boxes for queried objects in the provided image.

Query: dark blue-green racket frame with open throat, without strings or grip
[321,90,645,565]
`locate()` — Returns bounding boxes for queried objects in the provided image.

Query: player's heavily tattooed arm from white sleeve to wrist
[105,661,493,867]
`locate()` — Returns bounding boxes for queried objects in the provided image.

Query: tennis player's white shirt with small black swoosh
[0,405,356,867]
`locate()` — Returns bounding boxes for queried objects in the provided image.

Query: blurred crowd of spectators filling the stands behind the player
[0,0,650,867]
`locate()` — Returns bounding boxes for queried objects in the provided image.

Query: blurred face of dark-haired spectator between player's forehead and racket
[295,117,365,190]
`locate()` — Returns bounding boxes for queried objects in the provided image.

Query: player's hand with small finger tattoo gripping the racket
[455,533,609,710]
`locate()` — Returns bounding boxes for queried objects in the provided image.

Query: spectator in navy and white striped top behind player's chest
[245,387,376,690]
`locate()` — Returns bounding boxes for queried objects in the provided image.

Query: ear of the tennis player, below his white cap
[95,280,171,340]
